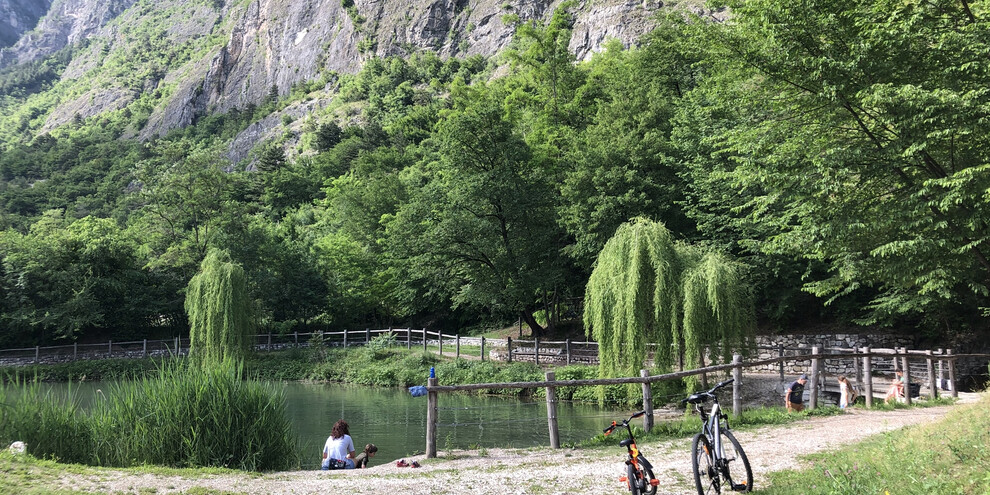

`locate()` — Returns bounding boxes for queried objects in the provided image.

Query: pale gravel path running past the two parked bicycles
[49,394,978,495]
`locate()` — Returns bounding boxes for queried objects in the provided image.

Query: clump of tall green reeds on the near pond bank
[0,362,299,471]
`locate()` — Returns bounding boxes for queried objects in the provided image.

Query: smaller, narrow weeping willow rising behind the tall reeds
[185,250,253,365]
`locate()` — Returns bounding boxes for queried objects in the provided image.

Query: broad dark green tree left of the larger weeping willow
[388,89,563,336]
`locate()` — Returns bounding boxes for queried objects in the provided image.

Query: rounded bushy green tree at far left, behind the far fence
[0,210,171,343]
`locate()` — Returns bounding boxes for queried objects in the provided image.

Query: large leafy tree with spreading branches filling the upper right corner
[686,0,990,330]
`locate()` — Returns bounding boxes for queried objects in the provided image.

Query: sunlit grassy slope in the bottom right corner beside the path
[757,394,990,495]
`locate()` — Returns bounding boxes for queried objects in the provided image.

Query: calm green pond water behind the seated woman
[13,382,629,469]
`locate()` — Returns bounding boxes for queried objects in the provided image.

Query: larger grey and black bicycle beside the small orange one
[681,378,753,495]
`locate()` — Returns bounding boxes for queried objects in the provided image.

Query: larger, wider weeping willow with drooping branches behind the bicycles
[584,219,754,386]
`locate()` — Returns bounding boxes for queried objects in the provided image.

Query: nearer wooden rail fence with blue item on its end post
[426,347,990,458]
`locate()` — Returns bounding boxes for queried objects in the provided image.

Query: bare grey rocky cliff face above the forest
[0,0,692,146]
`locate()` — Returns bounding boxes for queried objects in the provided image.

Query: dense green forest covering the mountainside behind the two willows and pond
[0,0,990,347]
